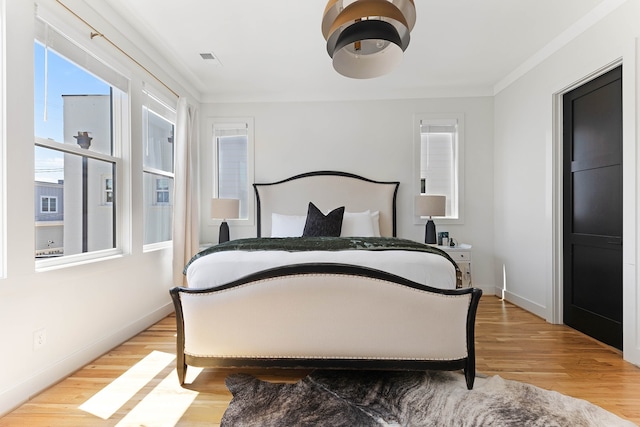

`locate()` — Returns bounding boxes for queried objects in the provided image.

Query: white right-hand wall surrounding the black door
[493,0,640,364]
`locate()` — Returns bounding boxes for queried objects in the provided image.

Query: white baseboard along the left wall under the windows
[0,303,174,416]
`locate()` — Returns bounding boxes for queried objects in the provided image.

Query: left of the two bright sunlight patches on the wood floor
[80,351,176,420]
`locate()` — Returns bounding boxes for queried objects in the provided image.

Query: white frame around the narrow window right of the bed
[413,113,465,225]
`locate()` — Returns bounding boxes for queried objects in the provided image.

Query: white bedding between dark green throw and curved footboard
[186,250,456,289]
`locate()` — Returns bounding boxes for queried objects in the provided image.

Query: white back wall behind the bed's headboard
[200,97,495,293]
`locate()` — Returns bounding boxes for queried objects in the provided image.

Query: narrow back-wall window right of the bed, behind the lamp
[415,114,464,223]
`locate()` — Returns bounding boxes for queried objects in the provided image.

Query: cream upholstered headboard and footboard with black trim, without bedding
[170,172,482,388]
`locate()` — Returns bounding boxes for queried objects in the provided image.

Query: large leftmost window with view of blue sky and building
[34,18,128,267]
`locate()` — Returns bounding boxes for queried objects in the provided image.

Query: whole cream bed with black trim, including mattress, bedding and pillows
[171,171,482,388]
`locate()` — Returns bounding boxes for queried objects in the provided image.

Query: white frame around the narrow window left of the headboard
[208,117,255,227]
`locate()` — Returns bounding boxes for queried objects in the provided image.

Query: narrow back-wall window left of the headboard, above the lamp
[212,119,253,220]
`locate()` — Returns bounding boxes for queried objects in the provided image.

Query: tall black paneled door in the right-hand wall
[563,66,622,349]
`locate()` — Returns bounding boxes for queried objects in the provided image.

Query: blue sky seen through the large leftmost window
[34,42,110,182]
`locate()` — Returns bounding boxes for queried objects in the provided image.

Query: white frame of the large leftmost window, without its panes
[34,15,131,271]
